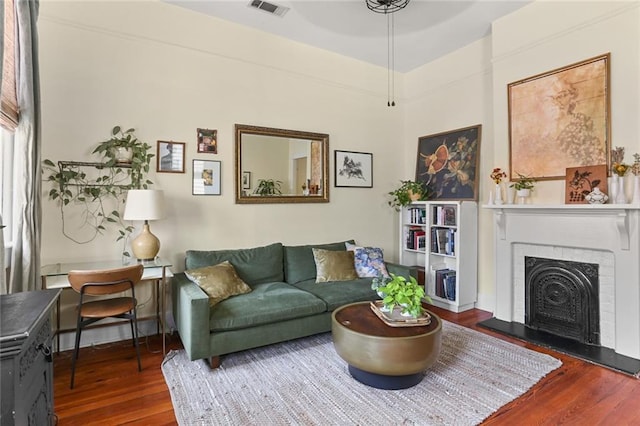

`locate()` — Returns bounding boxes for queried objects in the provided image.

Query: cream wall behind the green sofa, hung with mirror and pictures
[39,2,401,269]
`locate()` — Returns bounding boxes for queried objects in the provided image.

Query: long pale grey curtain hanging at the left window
[8,0,42,293]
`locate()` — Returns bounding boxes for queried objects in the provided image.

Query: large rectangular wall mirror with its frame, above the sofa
[235,124,329,204]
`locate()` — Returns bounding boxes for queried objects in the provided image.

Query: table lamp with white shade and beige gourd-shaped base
[124,189,164,260]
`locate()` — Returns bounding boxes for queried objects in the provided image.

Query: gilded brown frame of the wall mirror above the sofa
[235,124,330,204]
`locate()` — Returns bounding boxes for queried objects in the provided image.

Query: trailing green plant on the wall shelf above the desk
[43,126,154,248]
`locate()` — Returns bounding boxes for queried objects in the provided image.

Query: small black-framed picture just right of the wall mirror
[333,151,373,188]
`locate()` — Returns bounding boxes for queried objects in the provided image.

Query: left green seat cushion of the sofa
[209,282,327,332]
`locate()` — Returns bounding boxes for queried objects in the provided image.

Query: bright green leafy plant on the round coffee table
[377,274,431,318]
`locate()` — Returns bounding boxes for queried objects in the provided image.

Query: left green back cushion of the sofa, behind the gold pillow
[185,243,284,287]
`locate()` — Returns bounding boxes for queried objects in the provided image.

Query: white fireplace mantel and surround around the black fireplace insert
[483,204,640,359]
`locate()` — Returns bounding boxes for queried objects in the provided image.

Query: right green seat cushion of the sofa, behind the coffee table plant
[296,278,379,311]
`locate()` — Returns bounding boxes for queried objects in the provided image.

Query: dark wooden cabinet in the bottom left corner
[0,290,60,426]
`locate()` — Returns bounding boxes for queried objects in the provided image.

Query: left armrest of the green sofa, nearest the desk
[171,273,210,361]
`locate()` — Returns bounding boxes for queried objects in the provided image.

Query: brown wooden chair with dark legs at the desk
[69,265,144,389]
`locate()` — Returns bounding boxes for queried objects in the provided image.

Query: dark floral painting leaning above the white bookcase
[416,124,482,201]
